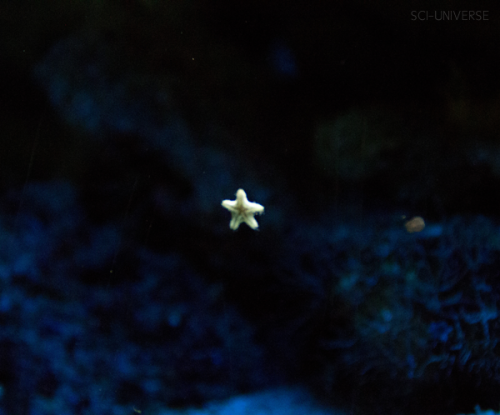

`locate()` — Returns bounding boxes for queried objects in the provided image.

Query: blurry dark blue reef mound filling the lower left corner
[0,182,276,415]
